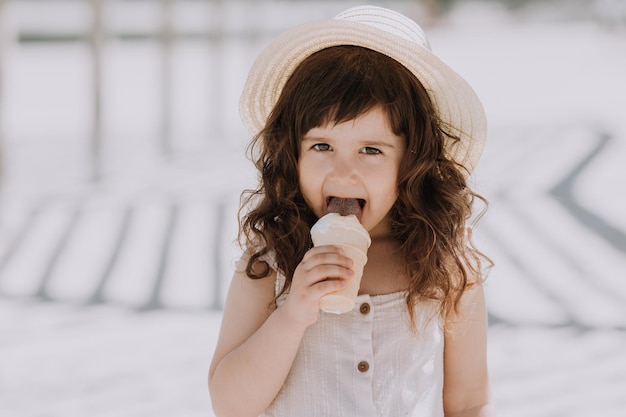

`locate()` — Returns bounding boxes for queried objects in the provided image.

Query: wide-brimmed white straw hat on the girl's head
[239,6,487,172]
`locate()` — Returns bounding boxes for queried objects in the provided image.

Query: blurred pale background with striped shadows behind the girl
[0,0,626,417]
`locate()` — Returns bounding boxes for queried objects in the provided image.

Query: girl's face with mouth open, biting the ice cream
[298,107,405,236]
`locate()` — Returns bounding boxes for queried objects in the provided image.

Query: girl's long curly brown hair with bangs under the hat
[239,45,490,317]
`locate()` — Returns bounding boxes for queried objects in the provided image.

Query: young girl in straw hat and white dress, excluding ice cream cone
[209,6,493,417]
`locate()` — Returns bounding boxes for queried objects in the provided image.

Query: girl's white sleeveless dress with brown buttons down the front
[261,274,444,417]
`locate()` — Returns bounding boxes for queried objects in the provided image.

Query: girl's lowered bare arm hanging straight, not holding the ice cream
[443,285,495,417]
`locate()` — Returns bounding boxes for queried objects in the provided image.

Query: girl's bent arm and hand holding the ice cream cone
[209,247,351,417]
